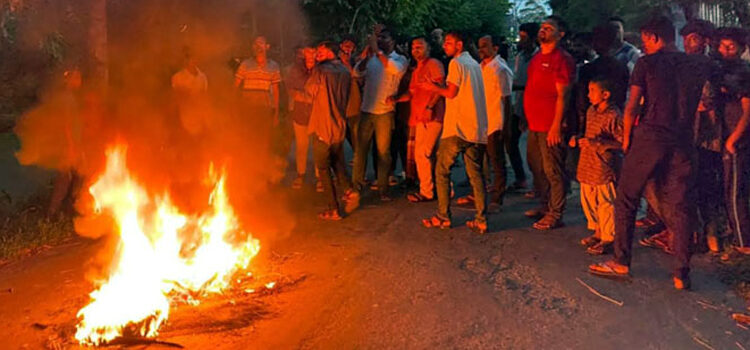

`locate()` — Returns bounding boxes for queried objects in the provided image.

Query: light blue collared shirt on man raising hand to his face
[354,51,408,114]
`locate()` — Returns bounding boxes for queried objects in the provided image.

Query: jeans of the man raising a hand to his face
[352,112,394,194]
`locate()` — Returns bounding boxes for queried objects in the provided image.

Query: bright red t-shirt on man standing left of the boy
[523,48,576,132]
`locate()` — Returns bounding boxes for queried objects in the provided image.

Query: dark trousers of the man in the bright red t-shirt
[526,131,566,219]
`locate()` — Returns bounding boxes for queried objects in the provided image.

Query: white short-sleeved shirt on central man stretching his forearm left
[441,51,487,143]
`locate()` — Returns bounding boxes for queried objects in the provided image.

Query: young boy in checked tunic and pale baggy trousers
[569,78,622,255]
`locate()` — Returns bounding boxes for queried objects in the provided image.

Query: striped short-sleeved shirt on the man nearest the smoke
[235,58,281,107]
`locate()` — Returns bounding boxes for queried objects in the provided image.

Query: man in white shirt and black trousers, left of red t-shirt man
[479,35,513,205]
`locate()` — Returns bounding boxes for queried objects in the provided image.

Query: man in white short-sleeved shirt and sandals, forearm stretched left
[421,32,487,234]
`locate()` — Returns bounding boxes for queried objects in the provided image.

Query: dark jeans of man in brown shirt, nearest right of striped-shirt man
[312,135,351,210]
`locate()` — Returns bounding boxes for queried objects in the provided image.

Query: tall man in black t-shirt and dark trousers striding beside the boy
[589,17,708,289]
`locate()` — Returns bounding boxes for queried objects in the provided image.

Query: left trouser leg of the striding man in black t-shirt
[615,140,666,266]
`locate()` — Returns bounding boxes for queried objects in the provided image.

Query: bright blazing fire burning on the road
[75,145,260,345]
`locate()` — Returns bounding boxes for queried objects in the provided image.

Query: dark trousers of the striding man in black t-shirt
[614,138,696,277]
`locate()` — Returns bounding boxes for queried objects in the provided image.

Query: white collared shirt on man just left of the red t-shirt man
[482,55,513,135]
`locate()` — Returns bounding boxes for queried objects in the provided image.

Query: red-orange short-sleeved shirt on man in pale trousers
[409,58,445,126]
